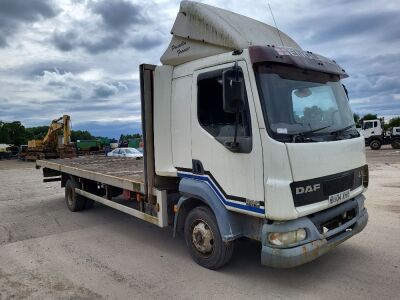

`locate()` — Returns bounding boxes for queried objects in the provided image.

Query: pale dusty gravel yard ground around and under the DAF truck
[0,147,400,299]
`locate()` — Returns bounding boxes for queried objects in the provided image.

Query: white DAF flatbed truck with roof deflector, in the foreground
[37,1,368,269]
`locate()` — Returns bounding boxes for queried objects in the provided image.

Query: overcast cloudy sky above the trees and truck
[0,0,400,137]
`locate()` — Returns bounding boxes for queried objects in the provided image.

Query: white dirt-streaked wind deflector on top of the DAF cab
[161,1,301,66]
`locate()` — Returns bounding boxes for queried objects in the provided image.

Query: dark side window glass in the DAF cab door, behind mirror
[197,70,251,137]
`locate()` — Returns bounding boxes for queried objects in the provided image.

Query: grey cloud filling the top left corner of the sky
[0,0,59,47]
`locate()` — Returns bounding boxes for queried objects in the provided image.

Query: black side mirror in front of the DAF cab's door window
[222,63,245,113]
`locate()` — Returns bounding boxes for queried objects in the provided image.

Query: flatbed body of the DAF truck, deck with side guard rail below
[36,156,168,227]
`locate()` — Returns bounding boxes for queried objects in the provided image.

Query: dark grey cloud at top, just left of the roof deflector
[51,0,164,54]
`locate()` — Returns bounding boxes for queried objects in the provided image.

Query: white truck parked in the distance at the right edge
[360,118,400,150]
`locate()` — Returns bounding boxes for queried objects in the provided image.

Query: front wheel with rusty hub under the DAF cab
[184,206,234,270]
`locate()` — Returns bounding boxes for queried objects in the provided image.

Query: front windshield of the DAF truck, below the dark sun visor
[256,64,359,142]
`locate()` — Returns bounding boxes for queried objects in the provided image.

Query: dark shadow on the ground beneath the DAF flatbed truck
[89,206,367,282]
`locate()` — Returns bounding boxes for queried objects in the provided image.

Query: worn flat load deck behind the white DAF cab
[36,156,145,193]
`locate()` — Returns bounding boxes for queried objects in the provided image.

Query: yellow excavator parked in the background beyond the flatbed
[25,115,76,161]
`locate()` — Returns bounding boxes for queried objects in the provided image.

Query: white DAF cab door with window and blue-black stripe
[190,61,265,215]
